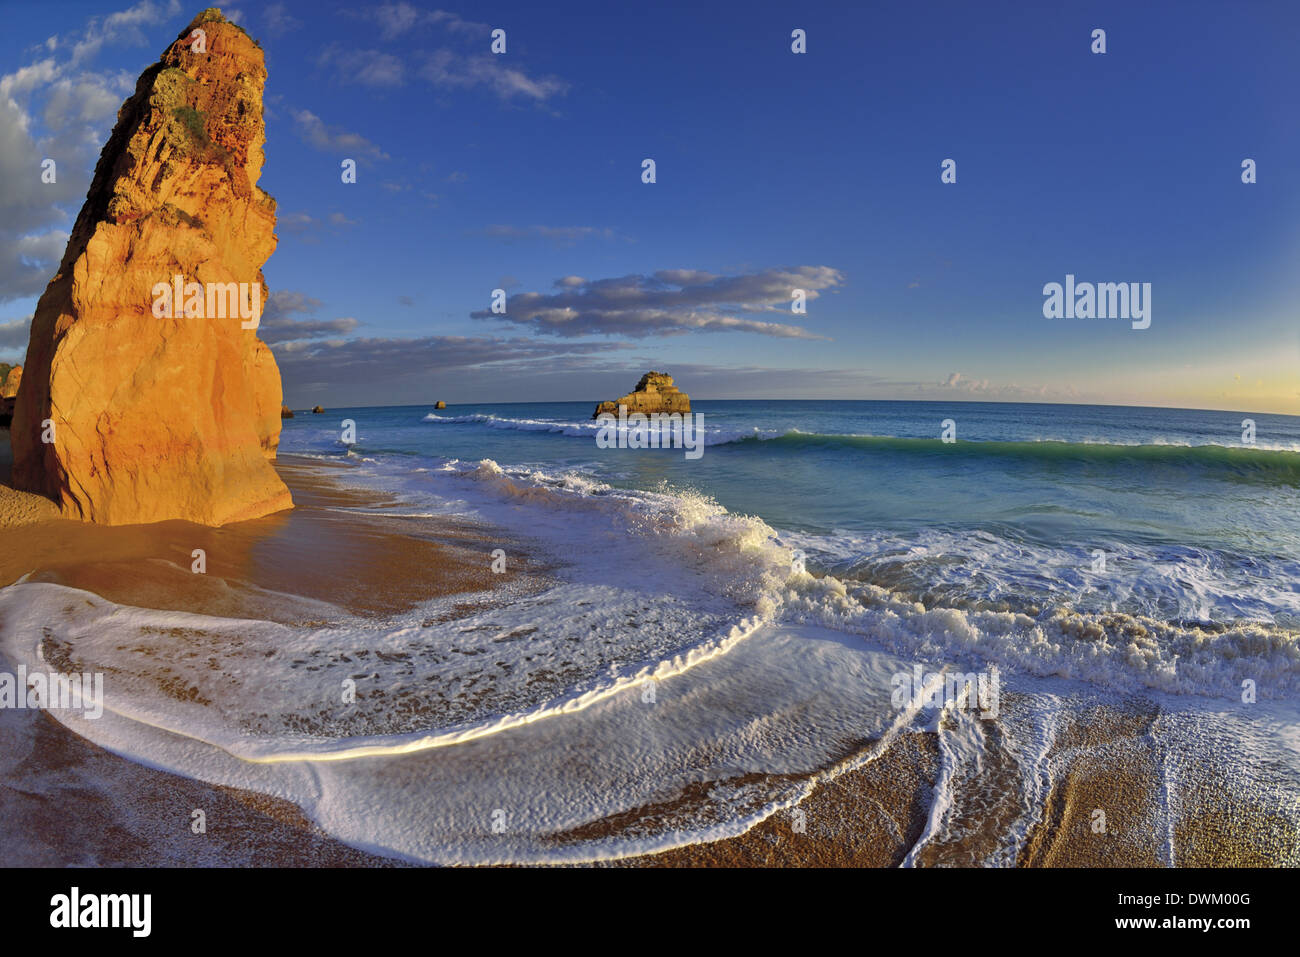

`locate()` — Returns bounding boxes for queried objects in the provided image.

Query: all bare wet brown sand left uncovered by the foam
[0,442,1300,867]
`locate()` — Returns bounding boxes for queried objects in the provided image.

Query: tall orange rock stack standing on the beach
[13,9,293,525]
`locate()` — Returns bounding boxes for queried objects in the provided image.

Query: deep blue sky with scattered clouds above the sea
[0,0,1300,413]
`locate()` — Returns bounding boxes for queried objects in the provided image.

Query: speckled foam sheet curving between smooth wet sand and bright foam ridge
[0,462,789,761]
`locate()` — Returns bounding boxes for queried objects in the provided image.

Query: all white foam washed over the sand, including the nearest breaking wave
[0,444,1300,863]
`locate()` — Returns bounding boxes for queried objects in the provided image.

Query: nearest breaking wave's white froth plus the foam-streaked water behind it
[263,459,1300,698]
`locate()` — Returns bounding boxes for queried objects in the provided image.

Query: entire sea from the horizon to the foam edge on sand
[0,400,1300,865]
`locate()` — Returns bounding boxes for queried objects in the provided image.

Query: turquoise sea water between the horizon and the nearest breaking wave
[281,400,1300,628]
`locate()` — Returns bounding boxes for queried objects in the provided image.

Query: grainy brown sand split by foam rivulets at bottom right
[588,698,1300,867]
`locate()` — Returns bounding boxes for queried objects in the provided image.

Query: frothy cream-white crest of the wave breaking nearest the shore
[379,460,1300,697]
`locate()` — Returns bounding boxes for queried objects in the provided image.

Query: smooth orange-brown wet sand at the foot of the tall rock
[0,442,495,622]
